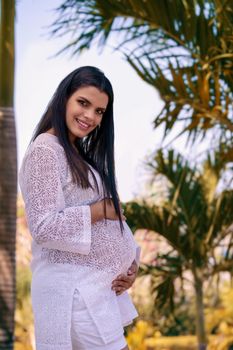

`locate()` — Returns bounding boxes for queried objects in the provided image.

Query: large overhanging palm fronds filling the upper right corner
[51,0,233,154]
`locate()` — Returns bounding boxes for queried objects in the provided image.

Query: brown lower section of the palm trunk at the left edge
[0,107,17,350]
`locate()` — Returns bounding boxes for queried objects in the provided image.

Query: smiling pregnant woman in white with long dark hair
[19,66,139,350]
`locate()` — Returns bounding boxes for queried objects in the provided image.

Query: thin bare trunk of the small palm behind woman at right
[193,268,207,350]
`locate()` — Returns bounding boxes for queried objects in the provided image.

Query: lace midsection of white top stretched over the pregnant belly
[42,220,136,277]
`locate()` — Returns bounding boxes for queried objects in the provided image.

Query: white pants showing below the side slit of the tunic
[71,289,127,350]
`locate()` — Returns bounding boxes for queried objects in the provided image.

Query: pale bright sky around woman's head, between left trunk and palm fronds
[15,0,166,201]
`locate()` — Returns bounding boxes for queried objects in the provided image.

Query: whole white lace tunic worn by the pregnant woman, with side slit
[19,133,139,350]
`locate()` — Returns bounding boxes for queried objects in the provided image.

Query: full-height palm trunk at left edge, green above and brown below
[0,0,17,350]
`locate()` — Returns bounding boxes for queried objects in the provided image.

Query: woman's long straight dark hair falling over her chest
[31,66,123,230]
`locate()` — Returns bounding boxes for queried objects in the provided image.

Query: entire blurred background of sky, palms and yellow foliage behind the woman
[0,0,233,350]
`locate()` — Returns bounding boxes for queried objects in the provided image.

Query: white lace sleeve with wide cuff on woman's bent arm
[20,145,91,254]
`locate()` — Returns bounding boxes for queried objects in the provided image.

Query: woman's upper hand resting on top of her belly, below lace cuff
[90,198,126,223]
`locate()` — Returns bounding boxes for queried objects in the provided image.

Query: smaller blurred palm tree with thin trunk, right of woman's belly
[125,150,233,349]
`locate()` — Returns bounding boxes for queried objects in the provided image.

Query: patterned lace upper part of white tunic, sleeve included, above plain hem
[20,134,136,275]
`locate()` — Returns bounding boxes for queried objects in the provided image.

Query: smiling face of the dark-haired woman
[66,86,108,143]
